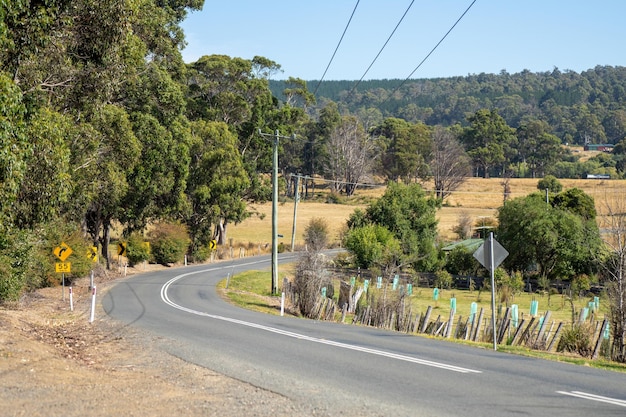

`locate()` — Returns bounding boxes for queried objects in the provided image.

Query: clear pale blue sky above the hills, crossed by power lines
[182,0,626,80]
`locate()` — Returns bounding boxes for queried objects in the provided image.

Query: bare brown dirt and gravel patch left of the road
[0,264,312,417]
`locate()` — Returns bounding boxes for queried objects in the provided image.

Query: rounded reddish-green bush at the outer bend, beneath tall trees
[148,223,189,265]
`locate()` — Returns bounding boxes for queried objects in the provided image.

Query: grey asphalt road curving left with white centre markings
[102,254,626,417]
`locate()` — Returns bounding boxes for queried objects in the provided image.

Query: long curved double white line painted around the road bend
[161,262,482,374]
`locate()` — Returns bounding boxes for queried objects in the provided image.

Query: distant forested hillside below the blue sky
[270,66,626,145]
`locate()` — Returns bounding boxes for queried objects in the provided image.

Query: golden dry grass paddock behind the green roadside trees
[228,178,626,247]
